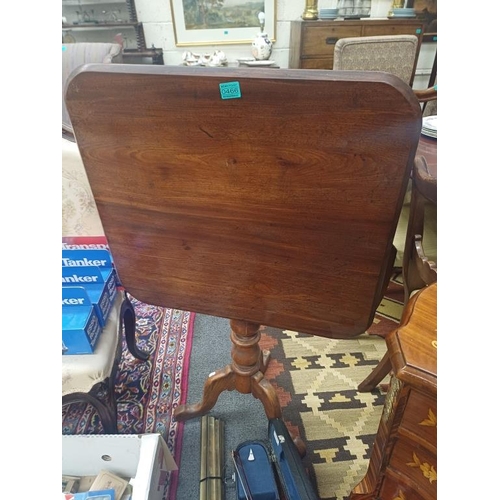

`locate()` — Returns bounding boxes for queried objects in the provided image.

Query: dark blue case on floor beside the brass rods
[233,418,318,500]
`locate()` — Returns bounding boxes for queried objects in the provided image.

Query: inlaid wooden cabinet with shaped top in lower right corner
[350,284,437,500]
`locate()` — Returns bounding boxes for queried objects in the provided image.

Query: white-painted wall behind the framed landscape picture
[135,0,436,88]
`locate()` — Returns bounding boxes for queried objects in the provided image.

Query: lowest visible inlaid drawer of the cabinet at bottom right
[387,438,437,498]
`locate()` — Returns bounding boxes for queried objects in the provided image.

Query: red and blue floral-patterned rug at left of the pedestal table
[62,297,195,498]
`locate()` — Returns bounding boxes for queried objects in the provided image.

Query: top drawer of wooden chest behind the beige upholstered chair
[301,24,361,57]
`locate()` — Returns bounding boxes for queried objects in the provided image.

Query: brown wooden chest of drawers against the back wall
[288,19,424,81]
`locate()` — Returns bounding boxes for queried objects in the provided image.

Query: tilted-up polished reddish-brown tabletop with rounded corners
[66,64,421,338]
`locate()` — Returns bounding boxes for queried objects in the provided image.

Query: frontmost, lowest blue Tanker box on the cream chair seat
[62,286,102,355]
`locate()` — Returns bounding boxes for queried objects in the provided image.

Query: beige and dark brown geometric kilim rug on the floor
[260,275,403,500]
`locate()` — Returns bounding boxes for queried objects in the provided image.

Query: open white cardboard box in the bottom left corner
[62,434,177,500]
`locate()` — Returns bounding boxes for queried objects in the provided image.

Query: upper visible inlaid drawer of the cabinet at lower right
[400,390,437,452]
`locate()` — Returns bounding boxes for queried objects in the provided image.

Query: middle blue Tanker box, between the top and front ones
[62,266,116,327]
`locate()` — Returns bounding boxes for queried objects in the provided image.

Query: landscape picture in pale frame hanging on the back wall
[170,0,276,47]
